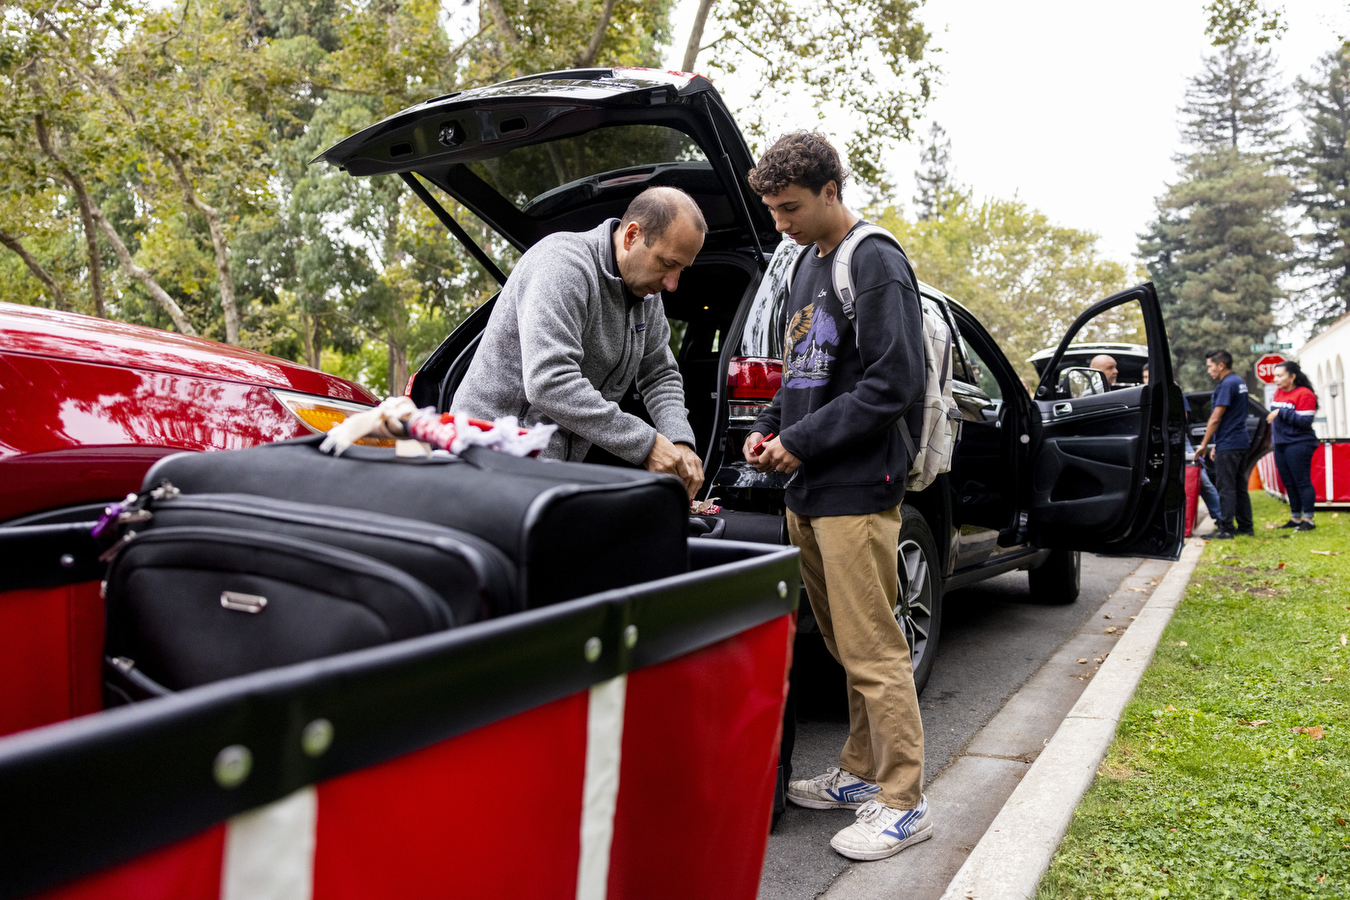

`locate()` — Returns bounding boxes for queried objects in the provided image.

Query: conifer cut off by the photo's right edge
[1297,47,1350,328]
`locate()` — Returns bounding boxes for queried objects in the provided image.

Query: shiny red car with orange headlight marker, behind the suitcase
[0,304,378,525]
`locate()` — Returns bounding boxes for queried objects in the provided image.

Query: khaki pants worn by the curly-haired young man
[787,506,923,810]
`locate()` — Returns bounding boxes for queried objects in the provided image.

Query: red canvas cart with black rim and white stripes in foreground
[0,524,799,900]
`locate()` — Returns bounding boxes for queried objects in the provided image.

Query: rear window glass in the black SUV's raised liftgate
[467,125,713,216]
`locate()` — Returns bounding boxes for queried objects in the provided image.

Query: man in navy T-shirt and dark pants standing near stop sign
[1195,349,1256,541]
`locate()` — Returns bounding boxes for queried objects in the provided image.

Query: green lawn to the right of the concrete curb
[1037,493,1350,900]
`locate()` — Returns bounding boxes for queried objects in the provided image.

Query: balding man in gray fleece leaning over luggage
[450,188,707,497]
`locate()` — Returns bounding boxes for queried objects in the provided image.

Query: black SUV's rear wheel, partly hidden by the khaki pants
[895,505,942,692]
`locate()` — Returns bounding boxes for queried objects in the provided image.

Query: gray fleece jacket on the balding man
[450,219,694,466]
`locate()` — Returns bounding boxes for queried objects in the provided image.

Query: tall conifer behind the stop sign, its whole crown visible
[1139,40,1293,390]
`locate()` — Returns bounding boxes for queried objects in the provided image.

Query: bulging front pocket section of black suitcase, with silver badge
[104,526,455,703]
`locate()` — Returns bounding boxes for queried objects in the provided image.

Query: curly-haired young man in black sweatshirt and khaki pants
[744,132,933,860]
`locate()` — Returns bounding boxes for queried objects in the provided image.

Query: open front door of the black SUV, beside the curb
[1027,283,1185,559]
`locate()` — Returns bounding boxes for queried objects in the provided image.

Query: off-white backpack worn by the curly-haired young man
[787,224,961,491]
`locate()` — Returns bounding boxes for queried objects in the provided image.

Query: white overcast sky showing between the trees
[668,0,1350,262]
